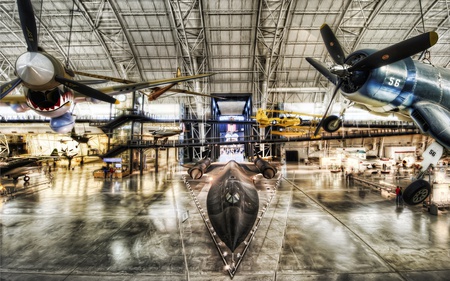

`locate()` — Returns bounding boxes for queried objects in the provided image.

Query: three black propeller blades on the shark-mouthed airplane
[0,0,119,103]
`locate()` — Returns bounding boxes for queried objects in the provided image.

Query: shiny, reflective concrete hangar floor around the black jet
[0,161,450,281]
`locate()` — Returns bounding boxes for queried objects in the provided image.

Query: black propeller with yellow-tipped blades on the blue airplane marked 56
[306,23,438,136]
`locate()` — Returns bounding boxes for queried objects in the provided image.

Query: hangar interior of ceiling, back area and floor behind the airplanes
[0,0,450,280]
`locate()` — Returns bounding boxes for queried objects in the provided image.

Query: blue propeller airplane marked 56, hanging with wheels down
[306,24,450,204]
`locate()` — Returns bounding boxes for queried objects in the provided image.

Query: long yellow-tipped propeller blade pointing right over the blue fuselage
[348,31,438,72]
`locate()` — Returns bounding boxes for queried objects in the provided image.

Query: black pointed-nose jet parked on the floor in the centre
[188,157,277,253]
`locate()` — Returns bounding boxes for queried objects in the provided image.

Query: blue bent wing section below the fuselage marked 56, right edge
[411,101,450,149]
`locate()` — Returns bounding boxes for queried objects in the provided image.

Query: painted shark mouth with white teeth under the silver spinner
[25,86,73,118]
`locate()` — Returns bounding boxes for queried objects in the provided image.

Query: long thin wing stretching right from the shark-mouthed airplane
[92,73,214,95]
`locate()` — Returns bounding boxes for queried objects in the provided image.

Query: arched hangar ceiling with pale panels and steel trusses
[0,0,450,110]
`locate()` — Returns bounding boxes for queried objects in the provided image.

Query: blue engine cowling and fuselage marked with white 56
[341,49,450,116]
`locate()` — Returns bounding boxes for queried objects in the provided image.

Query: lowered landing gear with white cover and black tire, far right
[403,142,444,205]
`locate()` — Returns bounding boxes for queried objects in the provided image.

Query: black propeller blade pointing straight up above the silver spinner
[17,0,38,52]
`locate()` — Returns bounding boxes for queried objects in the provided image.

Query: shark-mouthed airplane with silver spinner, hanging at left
[0,0,212,133]
